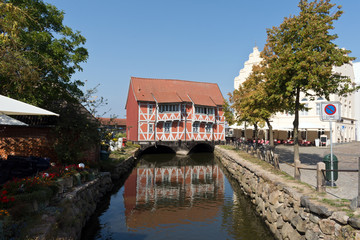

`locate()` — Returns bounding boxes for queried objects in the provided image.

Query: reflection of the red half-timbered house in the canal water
[124,165,225,228]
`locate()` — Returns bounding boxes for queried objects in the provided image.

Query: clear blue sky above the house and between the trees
[45,0,360,118]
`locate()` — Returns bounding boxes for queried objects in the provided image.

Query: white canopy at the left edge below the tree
[0,95,59,116]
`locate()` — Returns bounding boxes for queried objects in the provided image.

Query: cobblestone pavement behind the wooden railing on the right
[275,142,360,199]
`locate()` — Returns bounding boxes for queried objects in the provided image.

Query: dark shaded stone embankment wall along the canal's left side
[31,157,136,240]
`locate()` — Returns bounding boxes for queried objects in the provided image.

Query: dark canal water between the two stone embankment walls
[82,153,274,240]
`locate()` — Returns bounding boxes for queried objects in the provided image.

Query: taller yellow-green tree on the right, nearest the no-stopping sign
[262,0,354,161]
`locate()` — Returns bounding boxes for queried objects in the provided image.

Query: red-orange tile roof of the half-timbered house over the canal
[130,77,224,106]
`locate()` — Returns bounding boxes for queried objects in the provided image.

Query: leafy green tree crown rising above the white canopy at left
[0,0,88,107]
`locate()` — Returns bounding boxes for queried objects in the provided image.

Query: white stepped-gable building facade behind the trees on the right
[234,47,359,143]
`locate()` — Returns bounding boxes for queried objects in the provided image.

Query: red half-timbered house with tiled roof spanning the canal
[126,77,225,142]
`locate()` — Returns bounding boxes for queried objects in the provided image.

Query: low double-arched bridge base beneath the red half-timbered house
[137,140,223,155]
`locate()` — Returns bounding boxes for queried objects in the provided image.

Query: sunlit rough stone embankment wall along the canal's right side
[215,146,360,240]
